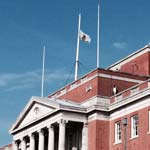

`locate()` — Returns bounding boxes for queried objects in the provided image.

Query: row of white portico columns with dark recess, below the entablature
[13,120,86,150]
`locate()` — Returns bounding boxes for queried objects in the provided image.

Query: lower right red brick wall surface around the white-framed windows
[110,107,150,150]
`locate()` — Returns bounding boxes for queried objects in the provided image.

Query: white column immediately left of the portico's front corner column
[48,125,54,150]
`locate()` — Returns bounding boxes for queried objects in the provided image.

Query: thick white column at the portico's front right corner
[58,119,66,150]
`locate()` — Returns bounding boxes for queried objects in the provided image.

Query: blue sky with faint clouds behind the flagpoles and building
[0,0,150,146]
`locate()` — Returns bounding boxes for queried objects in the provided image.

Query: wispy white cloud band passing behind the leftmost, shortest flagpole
[0,69,73,91]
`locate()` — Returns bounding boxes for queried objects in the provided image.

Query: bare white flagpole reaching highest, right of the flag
[97,4,100,68]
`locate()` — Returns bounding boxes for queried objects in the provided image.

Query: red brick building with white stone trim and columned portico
[2,45,150,150]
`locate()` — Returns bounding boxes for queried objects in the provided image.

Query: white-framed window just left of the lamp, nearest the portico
[115,121,121,143]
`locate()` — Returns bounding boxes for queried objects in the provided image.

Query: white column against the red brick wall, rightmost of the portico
[82,123,88,150]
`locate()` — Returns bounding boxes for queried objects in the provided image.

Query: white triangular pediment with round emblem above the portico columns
[10,97,59,132]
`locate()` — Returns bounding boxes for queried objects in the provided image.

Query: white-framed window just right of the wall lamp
[131,115,138,138]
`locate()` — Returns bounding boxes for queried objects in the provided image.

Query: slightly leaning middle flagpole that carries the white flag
[74,14,81,81]
